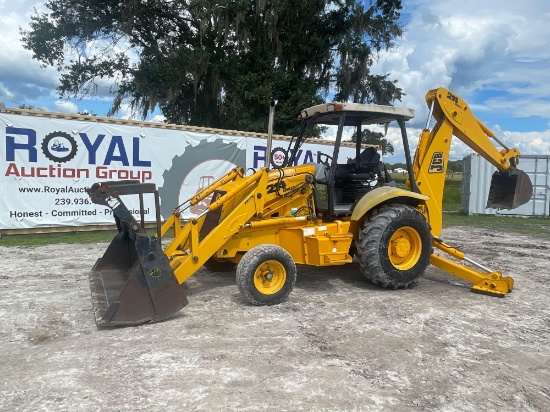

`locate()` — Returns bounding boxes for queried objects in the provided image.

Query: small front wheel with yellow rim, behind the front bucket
[237,245,296,306]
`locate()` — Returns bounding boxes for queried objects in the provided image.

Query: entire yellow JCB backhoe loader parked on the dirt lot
[88,88,532,326]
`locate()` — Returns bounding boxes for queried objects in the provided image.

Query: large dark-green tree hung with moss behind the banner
[22,0,402,133]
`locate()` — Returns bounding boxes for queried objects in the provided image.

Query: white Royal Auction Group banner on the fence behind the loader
[0,113,355,229]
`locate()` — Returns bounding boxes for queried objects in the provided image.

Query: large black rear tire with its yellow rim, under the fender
[357,204,433,289]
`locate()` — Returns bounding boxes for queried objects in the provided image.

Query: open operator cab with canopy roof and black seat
[285,102,414,217]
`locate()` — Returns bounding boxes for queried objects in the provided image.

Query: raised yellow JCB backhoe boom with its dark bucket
[412,88,532,236]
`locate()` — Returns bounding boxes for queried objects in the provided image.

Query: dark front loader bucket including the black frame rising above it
[88,181,188,326]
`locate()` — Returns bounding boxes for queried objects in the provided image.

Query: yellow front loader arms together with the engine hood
[161,165,320,283]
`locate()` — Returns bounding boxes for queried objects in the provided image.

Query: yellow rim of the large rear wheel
[388,226,422,270]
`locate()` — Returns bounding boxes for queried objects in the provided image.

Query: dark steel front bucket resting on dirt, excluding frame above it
[89,232,188,326]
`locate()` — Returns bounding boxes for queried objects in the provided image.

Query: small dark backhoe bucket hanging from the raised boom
[487,168,533,209]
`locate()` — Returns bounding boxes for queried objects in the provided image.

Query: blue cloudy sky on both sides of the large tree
[0,0,550,163]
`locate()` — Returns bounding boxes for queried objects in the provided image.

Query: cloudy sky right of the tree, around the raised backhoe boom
[368,0,550,163]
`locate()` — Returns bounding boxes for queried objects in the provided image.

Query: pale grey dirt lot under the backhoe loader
[0,228,550,411]
